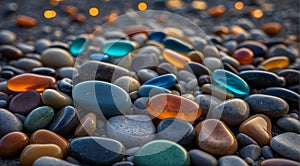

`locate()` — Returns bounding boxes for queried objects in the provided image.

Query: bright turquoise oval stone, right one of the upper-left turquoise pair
[102,40,134,57]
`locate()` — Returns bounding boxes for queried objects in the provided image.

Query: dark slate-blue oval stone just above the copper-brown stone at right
[245,94,289,118]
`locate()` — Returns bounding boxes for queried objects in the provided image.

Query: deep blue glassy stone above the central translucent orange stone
[144,74,177,89]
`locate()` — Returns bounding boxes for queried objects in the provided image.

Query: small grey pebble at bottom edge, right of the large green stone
[189,149,218,166]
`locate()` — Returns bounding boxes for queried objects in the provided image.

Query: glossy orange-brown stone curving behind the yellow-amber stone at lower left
[30,129,69,156]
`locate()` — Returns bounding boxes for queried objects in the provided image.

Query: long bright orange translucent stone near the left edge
[7,73,56,92]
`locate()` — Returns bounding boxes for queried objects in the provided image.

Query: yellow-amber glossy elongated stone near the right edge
[260,56,290,70]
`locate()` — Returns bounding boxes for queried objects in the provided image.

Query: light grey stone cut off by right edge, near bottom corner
[270,132,300,162]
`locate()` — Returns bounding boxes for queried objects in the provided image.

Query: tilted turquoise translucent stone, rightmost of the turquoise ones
[212,69,250,98]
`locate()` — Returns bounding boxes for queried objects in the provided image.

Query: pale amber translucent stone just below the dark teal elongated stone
[163,49,191,69]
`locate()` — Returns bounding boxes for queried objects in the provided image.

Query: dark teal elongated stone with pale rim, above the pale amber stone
[163,37,193,52]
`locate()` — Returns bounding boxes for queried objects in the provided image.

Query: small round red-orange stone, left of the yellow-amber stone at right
[232,48,254,65]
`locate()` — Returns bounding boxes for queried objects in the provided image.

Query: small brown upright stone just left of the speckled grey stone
[75,113,97,137]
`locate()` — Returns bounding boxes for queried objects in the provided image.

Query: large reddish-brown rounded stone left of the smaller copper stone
[196,119,238,155]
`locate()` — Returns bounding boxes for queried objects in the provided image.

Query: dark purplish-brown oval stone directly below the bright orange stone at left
[9,90,42,115]
